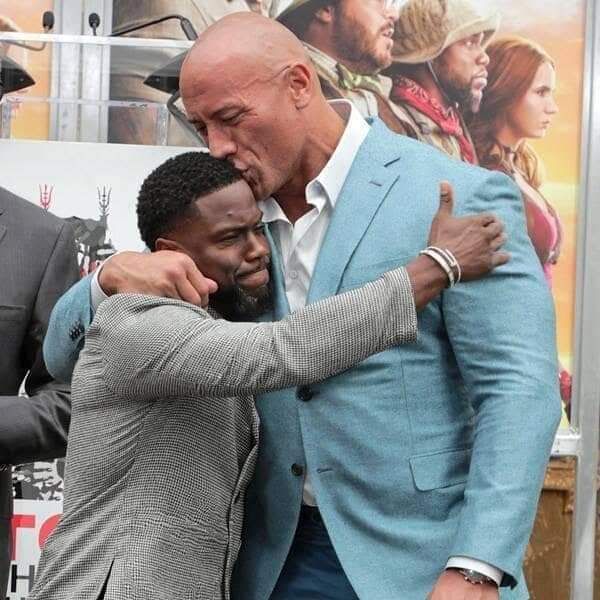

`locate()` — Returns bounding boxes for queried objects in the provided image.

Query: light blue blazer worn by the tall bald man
[45,120,560,600]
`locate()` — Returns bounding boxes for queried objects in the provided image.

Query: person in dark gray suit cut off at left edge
[0,187,78,597]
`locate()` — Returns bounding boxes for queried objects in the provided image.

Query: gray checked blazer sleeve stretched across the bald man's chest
[97,268,417,400]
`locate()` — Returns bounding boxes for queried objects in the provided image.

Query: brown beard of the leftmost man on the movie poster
[333,10,391,75]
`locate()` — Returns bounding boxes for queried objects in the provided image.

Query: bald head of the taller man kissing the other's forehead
[180,12,344,219]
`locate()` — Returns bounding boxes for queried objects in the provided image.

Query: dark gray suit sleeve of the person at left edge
[0,223,78,464]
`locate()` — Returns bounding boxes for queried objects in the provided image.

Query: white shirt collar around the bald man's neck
[259,100,369,223]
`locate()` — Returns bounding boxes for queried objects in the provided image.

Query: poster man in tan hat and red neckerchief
[387,0,500,164]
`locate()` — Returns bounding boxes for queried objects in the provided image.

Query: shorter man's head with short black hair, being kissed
[137,152,269,272]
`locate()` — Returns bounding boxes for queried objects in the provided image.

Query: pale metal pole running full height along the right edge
[571,0,600,600]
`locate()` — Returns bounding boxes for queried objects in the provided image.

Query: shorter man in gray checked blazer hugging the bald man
[30,152,508,600]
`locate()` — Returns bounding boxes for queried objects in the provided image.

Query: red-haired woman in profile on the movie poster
[469,36,571,412]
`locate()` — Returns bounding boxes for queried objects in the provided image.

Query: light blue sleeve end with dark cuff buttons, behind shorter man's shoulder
[44,275,93,382]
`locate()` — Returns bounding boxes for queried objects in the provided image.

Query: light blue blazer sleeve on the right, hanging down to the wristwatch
[442,173,561,586]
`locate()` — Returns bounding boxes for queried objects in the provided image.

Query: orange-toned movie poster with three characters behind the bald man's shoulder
[272,0,586,427]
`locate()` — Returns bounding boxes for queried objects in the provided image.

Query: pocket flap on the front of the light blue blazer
[409,448,471,492]
